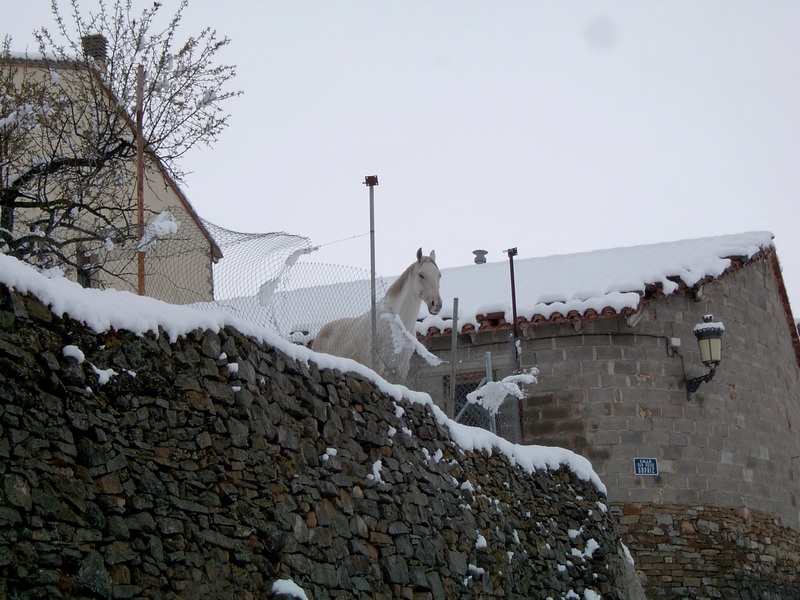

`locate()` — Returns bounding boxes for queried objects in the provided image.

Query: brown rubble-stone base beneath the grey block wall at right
[613,504,800,600]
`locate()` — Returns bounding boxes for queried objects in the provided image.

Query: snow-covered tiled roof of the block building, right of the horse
[417,231,773,333]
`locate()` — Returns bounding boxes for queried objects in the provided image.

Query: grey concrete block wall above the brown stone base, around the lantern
[419,254,800,529]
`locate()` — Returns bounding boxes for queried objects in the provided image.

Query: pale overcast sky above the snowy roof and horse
[6,0,800,316]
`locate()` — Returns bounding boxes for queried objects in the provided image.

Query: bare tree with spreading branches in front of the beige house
[0,0,241,272]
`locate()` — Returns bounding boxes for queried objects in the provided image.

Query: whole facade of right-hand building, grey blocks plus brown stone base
[410,237,800,598]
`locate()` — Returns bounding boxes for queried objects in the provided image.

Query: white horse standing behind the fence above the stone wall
[311,248,442,381]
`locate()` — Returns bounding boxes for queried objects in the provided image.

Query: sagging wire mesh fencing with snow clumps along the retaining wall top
[126,221,522,442]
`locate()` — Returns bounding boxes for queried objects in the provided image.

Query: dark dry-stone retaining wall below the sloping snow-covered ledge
[0,287,633,600]
